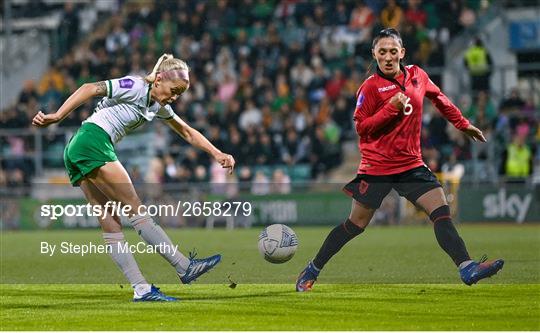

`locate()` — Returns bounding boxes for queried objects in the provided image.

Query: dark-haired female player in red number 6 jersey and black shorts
[296,29,504,291]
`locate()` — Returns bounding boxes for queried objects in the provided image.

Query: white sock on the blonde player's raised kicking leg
[129,215,189,275]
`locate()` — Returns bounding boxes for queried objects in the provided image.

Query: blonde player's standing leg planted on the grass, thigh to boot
[80,179,176,301]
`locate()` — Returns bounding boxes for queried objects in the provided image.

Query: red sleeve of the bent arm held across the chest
[354,84,399,136]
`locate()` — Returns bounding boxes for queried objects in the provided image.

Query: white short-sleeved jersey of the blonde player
[83,76,174,143]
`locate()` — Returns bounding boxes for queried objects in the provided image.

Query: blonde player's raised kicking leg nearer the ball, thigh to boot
[88,161,221,283]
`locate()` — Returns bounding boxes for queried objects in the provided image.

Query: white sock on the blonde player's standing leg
[103,232,148,286]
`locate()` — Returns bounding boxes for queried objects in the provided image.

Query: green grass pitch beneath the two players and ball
[0,225,540,330]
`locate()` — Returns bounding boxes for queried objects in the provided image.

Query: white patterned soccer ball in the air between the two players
[259,224,298,264]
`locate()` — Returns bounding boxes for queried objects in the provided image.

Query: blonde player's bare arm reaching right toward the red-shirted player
[167,115,236,174]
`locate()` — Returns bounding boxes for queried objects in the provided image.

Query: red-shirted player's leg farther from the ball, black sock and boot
[416,187,504,285]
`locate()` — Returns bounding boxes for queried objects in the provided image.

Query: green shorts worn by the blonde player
[64,123,118,186]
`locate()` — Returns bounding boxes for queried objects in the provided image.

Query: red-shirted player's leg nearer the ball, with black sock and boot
[296,199,375,292]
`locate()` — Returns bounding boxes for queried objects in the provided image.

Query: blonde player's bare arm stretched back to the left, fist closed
[32,81,107,127]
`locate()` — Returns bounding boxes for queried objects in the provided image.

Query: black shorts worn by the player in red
[343,166,441,209]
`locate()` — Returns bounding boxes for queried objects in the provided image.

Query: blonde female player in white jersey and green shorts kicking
[32,54,235,301]
